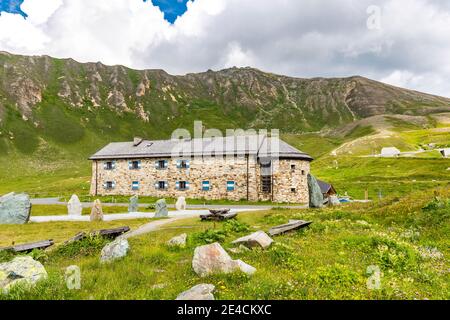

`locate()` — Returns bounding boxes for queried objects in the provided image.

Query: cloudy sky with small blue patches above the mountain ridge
[0,0,450,97]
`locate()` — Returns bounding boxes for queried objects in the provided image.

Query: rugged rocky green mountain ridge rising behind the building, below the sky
[0,52,450,152]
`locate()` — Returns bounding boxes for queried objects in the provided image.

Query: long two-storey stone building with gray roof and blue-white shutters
[90,136,312,203]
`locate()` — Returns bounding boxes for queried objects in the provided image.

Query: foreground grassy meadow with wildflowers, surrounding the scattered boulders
[0,189,450,300]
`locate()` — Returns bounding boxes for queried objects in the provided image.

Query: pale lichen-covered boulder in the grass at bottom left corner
[0,256,47,293]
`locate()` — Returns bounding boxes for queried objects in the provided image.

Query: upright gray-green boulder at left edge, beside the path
[0,192,31,224]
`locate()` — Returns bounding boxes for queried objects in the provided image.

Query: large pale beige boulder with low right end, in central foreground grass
[192,243,256,277]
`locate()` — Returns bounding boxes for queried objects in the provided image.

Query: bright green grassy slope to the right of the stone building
[284,115,450,199]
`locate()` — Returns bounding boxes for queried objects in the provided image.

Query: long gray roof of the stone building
[89,135,313,161]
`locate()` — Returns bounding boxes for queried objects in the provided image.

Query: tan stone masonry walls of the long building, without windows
[91,156,309,203]
